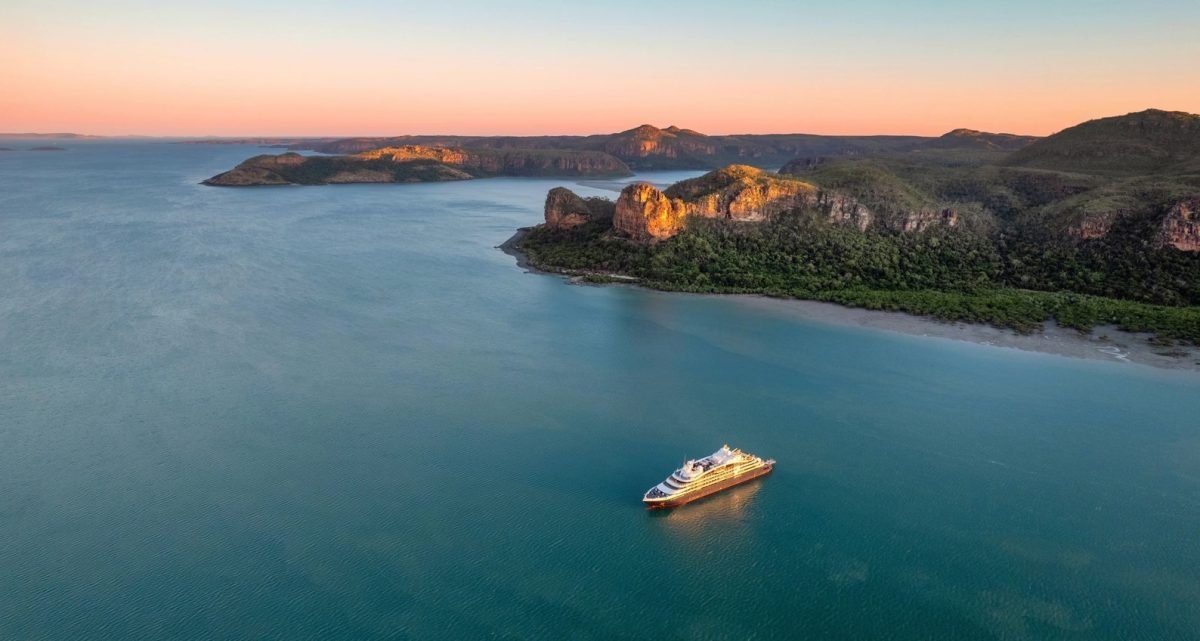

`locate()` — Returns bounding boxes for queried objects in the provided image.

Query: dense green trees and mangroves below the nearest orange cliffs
[521,211,1200,343]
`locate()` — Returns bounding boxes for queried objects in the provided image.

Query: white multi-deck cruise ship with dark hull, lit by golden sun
[642,445,775,509]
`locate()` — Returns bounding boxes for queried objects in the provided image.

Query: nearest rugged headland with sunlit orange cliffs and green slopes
[510,109,1200,354]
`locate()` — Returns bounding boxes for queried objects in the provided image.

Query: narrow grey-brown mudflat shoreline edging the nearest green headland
[497,227,1200,372]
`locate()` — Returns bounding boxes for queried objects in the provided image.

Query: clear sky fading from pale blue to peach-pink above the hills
[0,0,1200,136]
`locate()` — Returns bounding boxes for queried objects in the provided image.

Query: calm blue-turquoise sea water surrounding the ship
[0,143,1200,641]
